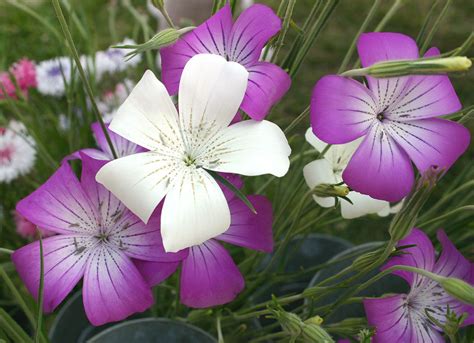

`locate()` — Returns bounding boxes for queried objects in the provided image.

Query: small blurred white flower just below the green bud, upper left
[95,38,142,79]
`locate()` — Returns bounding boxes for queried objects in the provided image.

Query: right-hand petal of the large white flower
[198,120,291,177]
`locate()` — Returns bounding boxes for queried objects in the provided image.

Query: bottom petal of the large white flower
[161,168,230,252]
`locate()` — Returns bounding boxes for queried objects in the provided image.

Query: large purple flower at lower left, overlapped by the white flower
[12,155,183,325]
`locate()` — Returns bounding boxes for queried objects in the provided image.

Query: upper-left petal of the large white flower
[110,70,182,150]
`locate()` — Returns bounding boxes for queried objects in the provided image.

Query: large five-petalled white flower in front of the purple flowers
[96,54,291,252]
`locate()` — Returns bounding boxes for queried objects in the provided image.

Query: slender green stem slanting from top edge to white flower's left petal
[51,0,118,158]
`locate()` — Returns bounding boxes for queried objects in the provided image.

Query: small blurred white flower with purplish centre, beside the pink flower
[36,57,71,96]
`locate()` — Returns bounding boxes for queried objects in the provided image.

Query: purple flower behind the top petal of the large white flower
[160,4,291,120]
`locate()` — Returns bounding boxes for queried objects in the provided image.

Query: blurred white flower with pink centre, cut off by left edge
[0,120,36,183]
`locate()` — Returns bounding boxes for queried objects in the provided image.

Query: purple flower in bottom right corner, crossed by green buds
[364,229,474,343]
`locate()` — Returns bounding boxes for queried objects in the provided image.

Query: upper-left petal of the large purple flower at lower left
[17,163,98,233]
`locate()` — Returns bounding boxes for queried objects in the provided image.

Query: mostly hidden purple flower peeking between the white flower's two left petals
[71,122,146,161]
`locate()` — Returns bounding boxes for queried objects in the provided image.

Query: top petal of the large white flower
[179,54,249,136]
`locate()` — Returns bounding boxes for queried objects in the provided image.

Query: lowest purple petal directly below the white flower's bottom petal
[180,240,244,308]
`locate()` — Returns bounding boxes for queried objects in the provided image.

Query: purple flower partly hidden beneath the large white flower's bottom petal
[136,181,273,308]
